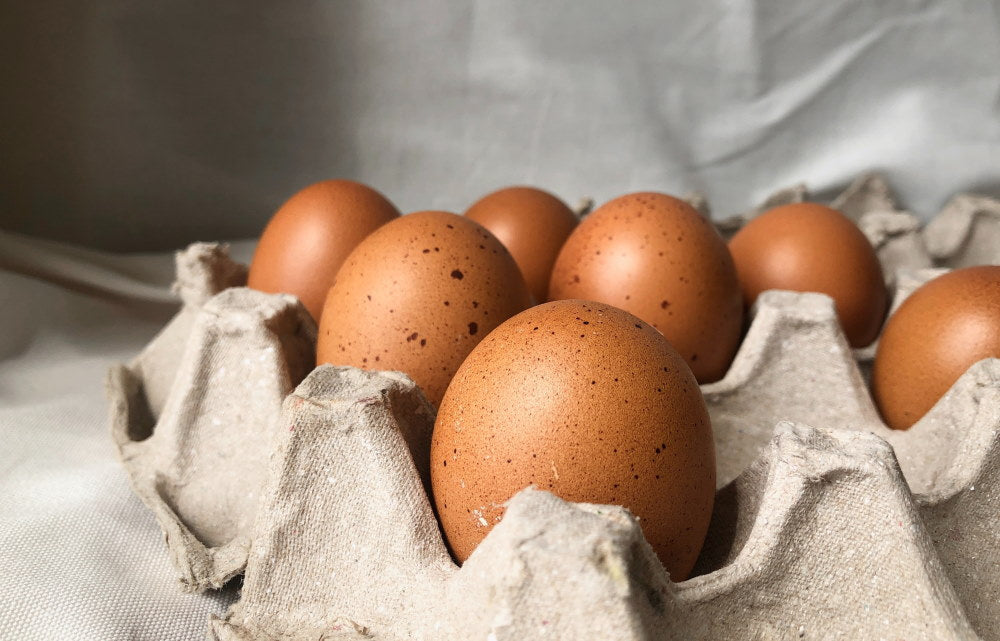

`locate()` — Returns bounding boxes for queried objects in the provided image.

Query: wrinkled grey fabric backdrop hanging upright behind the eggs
[0,0,1000,250]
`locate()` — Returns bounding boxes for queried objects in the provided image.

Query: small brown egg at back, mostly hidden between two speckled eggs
[465,187,579,303]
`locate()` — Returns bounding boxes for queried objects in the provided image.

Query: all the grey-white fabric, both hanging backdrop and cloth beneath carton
[0,0,1000,641]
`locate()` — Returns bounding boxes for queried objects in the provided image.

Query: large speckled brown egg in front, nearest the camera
[431,300,715,581]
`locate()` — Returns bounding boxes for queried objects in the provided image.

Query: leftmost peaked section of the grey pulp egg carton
[107,243,316,590]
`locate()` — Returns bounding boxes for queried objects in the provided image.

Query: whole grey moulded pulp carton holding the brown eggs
[108,175,1000,641]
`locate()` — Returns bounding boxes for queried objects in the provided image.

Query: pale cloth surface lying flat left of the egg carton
[0,232,258,641]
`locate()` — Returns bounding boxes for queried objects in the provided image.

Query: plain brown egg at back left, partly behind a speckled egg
[247,180,399,321]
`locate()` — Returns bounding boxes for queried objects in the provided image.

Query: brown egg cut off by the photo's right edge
[872,266,1000,430]
